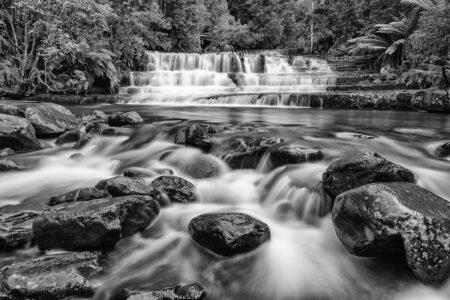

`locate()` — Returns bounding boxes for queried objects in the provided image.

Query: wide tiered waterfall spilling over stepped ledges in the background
[121,51,335,107]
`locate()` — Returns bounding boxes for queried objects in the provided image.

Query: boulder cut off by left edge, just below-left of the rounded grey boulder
[0,114,42,152]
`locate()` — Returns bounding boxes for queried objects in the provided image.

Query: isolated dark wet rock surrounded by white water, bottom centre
[189,213,270,256]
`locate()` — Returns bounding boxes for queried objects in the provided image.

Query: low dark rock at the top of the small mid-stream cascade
[269,144,323,168]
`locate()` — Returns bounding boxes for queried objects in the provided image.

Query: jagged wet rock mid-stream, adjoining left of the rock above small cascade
[219,136,282,169]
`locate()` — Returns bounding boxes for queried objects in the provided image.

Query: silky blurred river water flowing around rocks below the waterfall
[0,105,450,300]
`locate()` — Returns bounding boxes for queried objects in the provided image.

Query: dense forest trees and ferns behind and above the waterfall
[0,0,450,94]
